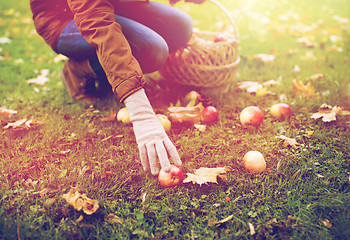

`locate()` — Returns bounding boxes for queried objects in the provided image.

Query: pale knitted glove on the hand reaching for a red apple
[124,89,181,175]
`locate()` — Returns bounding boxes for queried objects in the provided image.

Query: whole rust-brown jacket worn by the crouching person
[30,0,145,102]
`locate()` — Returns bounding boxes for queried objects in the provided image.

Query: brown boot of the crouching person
[61,59,98,103]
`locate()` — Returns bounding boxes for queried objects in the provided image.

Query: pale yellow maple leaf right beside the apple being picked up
[183,167,231,185]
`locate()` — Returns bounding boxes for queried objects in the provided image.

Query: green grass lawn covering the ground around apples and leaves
[0,0,350,239]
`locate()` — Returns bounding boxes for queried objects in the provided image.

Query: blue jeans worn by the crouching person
[57,2,192,74]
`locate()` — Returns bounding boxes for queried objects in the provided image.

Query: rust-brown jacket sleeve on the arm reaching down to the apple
[67,0,145,102]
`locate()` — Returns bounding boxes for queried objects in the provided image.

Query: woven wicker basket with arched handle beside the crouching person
[159,0,240,92]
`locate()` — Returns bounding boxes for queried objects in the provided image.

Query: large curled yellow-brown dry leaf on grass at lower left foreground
[62,188,99,215]
